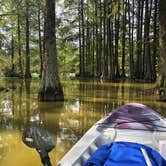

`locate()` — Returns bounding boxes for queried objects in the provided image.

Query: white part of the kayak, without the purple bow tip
[58,104,166,166]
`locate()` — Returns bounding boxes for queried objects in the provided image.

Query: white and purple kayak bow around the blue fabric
[58,103,166,166]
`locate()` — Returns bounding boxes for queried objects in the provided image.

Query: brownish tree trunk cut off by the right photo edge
[158,0,166,101]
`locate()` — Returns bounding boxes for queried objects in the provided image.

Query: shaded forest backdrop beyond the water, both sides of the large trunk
[0,0,165,85]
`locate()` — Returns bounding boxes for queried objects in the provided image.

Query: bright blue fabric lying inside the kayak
[84,142,166,166]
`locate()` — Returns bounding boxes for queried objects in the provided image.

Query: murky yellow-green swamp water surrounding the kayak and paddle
[0,79,166,166]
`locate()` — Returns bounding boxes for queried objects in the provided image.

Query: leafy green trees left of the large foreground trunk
[0,0,45,78]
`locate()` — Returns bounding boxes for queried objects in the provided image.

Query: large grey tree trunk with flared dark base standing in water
[38,0,64,101]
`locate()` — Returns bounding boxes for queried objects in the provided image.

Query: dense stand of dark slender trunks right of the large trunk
[75,0,159,82]
